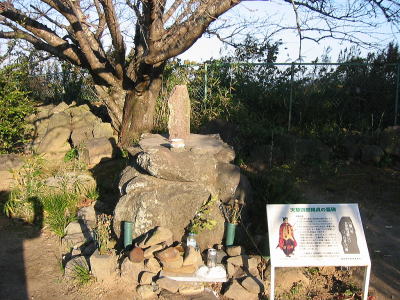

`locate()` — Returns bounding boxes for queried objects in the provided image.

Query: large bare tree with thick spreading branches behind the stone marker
[0,0,400,146]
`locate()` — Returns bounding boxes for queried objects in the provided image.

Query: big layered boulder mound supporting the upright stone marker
[114,134,250,249]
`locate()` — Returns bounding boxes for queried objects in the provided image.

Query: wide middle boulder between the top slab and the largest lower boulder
[137,148,217,183]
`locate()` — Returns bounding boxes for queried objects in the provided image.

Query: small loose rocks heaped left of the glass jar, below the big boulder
[120,227,208,299]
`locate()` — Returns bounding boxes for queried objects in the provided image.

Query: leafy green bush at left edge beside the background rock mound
[0,65,34,153]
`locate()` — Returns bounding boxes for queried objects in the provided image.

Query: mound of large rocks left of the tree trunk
[28,102,116,165]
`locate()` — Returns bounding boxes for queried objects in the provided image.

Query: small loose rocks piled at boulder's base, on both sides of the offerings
[120,227,267,300]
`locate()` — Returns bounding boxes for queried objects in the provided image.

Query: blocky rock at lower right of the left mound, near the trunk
[79,138,116,165]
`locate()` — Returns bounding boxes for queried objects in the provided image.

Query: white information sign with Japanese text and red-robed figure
[267,204,371,299]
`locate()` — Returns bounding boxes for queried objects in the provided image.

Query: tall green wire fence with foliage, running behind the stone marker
[25,61,400,134]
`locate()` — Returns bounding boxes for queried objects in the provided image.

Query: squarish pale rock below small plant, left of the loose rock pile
[89,251,117,281]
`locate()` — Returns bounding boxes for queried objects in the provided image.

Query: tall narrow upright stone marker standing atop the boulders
[168,85,190,140]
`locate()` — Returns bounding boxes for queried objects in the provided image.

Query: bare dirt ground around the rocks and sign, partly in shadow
[0,163,400,300]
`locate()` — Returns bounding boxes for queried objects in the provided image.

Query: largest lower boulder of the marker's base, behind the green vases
[113,174,211,244]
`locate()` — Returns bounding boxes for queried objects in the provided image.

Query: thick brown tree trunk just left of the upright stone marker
[119,77,162,147]
